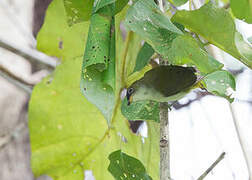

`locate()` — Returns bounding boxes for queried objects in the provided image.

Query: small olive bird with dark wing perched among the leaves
[126,65,200,105]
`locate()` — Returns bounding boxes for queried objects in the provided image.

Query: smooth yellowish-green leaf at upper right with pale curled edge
[172,2,252,68]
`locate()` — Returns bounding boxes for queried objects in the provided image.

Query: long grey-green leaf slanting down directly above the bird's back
[125,0,222,74]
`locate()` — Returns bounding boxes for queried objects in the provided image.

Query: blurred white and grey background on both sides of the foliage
[0,0,252,180]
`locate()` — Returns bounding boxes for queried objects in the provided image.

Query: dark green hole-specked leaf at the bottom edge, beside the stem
[108,150,152,180]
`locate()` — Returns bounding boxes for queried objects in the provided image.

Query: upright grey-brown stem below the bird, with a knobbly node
[160,102,171,180]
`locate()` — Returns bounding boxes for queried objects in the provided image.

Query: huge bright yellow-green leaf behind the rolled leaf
[29,0,159,180]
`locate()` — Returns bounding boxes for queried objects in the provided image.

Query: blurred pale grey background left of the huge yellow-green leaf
[0,0,51,180]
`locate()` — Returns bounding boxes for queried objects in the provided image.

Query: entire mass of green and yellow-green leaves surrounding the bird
[29,0,252,180]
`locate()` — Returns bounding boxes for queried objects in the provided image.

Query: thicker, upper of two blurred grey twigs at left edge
[0,39,57,68]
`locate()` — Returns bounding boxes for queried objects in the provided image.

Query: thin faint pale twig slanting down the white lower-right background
[229,103,252,180]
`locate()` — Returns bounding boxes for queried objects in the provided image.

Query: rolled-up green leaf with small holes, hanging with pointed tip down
[81,6,115,124]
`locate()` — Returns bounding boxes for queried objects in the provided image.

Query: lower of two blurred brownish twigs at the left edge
[0,66,32,94]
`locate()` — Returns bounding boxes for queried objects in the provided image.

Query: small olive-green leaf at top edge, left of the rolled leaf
[63,0,94,26]
